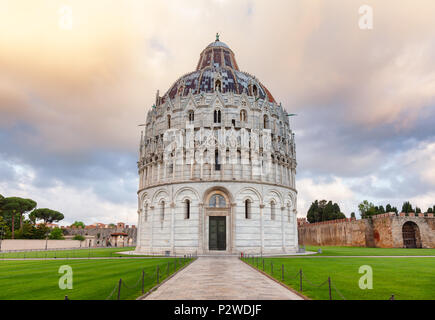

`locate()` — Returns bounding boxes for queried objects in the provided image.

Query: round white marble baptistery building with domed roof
[136,35,298,255]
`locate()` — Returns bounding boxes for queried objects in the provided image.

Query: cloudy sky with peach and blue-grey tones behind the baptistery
[0,0,435,225]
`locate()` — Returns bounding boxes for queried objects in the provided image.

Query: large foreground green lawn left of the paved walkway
[0,258,192,300]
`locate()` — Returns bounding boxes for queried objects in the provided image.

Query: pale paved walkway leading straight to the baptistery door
[145,257,302,300]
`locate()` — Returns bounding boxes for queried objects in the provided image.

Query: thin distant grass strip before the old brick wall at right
[306,246,435,256]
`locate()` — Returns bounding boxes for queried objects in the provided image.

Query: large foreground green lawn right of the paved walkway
[244,257,435,300]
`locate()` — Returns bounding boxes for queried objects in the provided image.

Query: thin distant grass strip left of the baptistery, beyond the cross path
[0,247,149,259]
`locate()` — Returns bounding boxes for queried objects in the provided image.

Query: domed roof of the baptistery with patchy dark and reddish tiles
[162,35,275,103]
